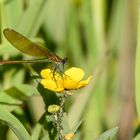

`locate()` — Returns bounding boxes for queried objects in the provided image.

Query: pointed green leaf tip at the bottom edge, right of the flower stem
[96,127,118,140]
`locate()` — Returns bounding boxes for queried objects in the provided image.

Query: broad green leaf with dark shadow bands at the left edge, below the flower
[0,84,39,111]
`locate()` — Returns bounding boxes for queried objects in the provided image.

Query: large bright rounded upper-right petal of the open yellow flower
[65,67,85,81]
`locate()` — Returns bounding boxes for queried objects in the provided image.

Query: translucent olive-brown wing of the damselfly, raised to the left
[3,29,53,58]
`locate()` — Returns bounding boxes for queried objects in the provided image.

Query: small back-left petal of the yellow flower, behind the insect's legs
[40,69,61,81]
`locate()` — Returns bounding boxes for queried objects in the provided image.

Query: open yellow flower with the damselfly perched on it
[41,67,92,92]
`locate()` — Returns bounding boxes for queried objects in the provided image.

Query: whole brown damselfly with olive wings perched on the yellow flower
[0,28,68,71]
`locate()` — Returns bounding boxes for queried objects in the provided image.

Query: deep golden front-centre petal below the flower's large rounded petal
[63,77,79,90]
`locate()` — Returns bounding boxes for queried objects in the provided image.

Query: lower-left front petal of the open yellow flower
[41,79,64,92]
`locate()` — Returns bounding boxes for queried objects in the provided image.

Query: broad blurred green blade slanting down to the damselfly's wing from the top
[16,0,45,36]
